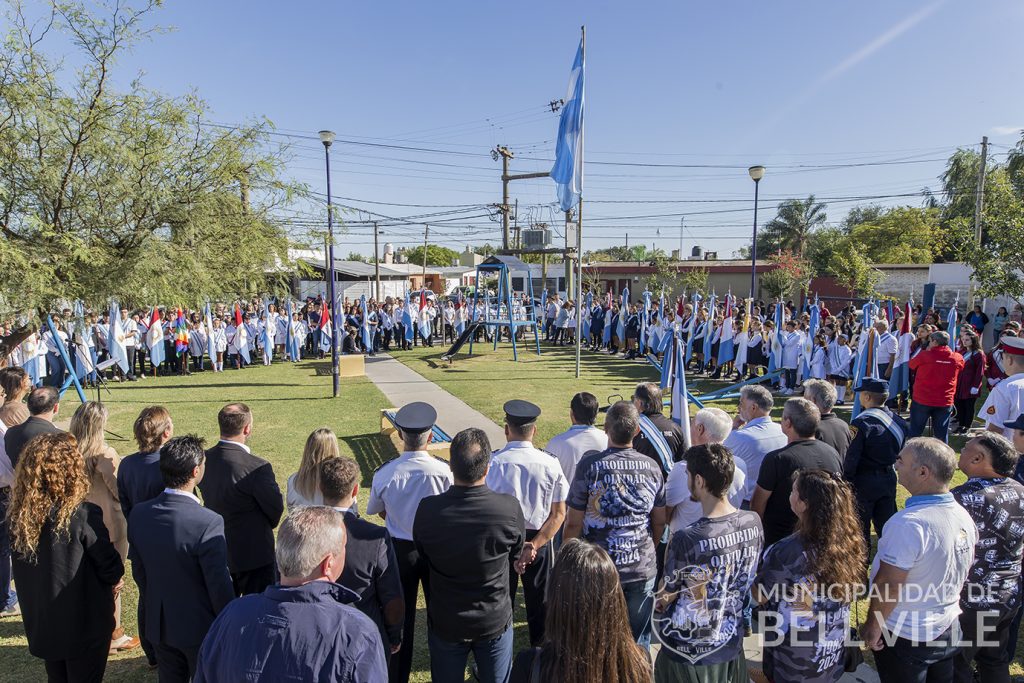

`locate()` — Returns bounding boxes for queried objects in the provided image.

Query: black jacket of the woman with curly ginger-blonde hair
[12,503,125,663]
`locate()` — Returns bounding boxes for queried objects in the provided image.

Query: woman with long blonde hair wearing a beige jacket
[70,400,139,652]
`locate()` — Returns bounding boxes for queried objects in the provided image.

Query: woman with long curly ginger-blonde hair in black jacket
[7,432,125,683]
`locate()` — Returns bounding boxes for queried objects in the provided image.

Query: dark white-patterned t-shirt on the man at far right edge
[952,477,1024,613]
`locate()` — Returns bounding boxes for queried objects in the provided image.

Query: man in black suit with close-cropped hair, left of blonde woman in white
[199,403,285,595]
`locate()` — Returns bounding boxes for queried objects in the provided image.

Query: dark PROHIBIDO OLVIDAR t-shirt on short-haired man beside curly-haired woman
[653,510,764,666]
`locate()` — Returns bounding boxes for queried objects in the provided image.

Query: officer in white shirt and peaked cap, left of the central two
[367,402,450,683]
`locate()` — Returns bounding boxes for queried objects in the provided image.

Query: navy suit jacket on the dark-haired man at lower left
[129,493,234,649]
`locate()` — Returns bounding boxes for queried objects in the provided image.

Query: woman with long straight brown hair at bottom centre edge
[509,539,652,683]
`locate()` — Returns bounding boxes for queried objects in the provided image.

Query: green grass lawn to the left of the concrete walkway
[0,361,525,681]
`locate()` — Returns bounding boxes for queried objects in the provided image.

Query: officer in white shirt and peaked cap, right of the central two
[486,400,569,646]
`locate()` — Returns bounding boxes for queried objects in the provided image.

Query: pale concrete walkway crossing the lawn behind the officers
[366,353,505,451]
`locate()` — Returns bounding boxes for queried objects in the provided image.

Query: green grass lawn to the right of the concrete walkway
[395,343,1024,681]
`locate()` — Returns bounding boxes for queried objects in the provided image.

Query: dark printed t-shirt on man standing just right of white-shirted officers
[567,447,665,584]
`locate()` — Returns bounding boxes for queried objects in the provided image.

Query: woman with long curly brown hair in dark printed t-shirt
[754,470,865,681]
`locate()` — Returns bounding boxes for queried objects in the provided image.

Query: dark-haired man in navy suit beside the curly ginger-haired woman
[128,435,234,683]
